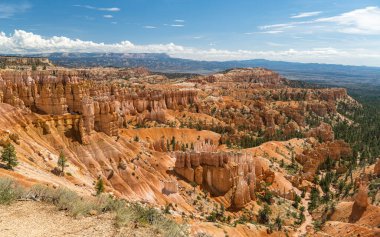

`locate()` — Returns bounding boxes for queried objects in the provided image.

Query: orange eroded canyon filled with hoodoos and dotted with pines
[0,63,380,236]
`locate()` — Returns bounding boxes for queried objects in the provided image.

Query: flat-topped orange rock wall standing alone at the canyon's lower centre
[174,152,256,208]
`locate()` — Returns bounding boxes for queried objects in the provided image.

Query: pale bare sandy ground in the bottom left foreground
[0,201,117,237]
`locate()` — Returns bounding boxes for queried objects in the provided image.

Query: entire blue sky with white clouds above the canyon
[0,0,380,67]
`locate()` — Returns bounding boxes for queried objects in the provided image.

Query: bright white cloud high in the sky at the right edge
[315,7,380,35]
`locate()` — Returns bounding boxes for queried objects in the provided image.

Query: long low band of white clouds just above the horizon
[0,30,380,66]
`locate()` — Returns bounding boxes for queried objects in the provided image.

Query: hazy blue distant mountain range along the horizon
[3,53,380,95]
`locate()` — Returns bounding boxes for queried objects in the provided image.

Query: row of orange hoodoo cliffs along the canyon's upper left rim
[0,70,197,143]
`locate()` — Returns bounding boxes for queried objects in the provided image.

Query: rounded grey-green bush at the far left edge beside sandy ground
[0,178,24,205]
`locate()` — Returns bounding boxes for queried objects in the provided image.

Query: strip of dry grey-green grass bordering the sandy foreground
[0,178,188,237]
